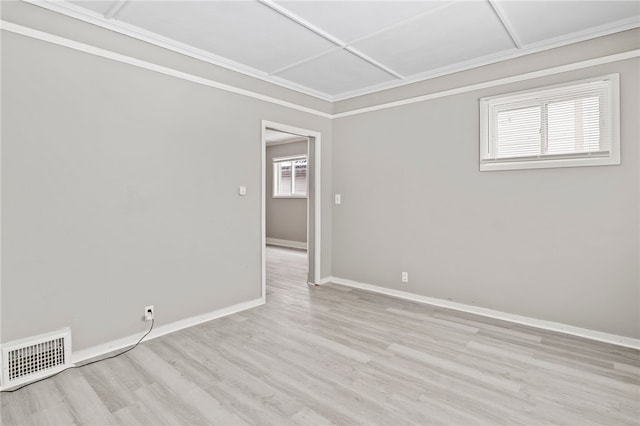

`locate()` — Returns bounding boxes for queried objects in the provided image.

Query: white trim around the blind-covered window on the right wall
[480,74,620,171]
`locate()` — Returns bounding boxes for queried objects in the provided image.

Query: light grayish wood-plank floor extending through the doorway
[1,247,640,425]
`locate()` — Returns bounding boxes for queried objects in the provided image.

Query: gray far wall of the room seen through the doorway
[266,141,308,243]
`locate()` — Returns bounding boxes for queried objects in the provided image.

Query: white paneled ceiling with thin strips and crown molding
[33,0,640,101]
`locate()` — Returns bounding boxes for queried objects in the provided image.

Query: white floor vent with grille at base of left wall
[2,328,71,389]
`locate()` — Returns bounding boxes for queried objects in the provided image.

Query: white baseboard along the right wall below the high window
[323,277,640,349]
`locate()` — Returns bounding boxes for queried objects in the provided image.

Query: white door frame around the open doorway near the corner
[260,120,322,300]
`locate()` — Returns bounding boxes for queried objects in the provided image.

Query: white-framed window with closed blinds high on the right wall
[480,74,620,171]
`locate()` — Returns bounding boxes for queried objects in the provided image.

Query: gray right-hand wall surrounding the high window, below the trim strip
[332,55,640,338]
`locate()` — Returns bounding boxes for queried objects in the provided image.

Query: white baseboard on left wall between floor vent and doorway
[71,298,265,364]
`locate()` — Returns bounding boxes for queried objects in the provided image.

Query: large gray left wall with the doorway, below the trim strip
[1,6,331,350]
